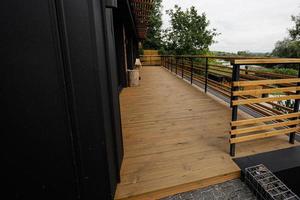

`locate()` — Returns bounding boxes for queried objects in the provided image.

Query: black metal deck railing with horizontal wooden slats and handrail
[141,55,300,156]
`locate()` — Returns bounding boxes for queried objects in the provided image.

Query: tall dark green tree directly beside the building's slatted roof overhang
[143,0,162,50]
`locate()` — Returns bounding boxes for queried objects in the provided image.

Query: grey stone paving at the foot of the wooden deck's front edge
[161,179,256,200]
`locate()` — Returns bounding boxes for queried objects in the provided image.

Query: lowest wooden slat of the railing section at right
[230,127,300,144]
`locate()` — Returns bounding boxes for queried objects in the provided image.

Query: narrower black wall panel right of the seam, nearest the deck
[59,0,119,199]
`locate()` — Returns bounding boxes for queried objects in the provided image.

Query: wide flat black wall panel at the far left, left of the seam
[0,0,77,199]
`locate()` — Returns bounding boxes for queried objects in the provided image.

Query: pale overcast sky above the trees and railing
[163,0,300,52]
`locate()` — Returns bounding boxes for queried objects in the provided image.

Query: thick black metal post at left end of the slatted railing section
[230,65,240,156]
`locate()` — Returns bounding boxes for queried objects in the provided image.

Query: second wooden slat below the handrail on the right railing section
[233,87,300,96]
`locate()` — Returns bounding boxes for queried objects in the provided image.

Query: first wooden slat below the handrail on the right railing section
[232,78,300,87]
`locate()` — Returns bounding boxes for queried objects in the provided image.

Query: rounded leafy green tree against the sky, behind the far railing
[164,5,217,55]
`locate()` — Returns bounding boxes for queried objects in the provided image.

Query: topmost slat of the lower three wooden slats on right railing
[230,112,300,126]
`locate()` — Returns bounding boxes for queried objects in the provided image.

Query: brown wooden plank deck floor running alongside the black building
[115,67,298,199]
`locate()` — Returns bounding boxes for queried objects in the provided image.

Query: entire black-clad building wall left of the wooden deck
[0,0,123,199]
